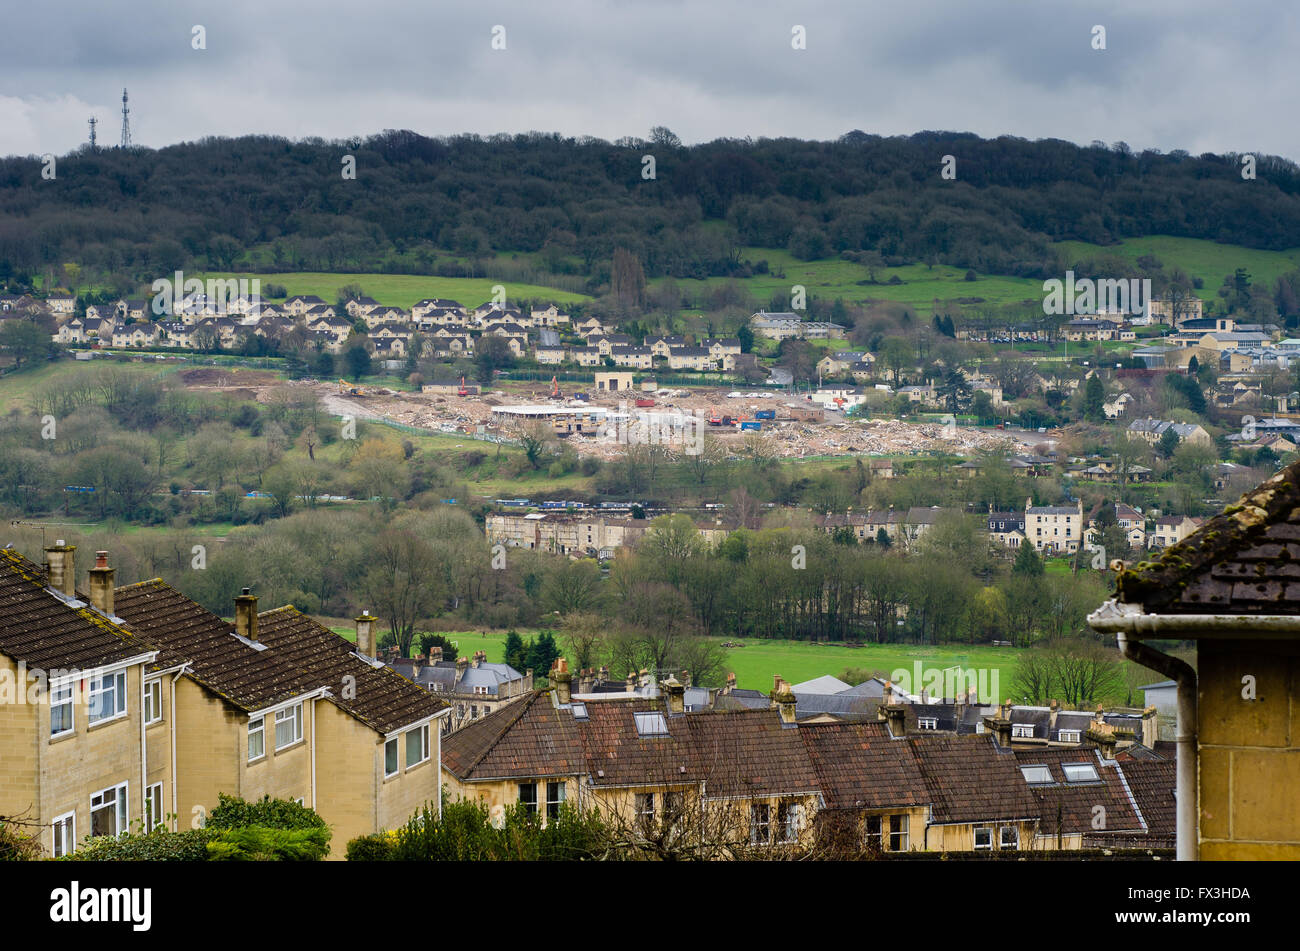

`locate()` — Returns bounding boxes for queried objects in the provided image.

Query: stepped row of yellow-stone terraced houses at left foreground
[0,546,449,857]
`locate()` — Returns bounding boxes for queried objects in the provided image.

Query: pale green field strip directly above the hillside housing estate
[198,272,588,308]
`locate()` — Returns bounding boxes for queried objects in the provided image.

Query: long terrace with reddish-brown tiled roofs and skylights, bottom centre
[442,661,1174,857]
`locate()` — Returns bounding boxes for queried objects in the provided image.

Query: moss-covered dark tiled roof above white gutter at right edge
[1117,463,1300,615]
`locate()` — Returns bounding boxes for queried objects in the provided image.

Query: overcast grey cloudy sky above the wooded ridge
[0,0,1300,160]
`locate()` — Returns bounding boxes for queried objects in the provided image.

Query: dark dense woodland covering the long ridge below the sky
[0,129,1300,292]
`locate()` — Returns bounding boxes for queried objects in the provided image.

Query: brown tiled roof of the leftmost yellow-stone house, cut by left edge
[0,548,153,670]
